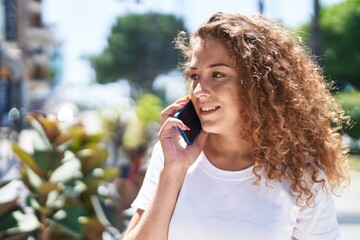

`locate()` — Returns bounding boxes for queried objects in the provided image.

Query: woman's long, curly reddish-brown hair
[175,13,348,204]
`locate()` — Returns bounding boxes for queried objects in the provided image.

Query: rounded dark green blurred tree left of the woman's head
[90,13,185,90]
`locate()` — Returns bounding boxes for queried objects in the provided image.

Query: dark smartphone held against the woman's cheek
[174,100,201,145]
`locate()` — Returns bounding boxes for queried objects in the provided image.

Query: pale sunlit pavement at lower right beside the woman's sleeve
[335,172,360,240]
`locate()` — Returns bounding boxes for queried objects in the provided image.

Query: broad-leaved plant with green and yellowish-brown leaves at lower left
[0,113,118,240]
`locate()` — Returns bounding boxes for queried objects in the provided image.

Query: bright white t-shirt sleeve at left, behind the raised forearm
[131,142,164,210]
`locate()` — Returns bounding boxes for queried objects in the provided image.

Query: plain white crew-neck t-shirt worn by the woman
[132,144,340,240]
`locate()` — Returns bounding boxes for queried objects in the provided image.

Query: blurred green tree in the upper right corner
[301,0,360,88]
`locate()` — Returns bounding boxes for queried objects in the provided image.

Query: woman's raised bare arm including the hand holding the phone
[124,98,207,240]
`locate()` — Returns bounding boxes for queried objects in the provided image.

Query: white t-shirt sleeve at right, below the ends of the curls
[293,181,340,240]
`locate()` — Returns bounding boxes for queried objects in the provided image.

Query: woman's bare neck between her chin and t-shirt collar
[204,134,254,171]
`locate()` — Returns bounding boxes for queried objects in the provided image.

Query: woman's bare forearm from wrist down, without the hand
[124,169,184,240]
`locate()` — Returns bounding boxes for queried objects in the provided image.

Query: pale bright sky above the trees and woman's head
[42,0,342,85]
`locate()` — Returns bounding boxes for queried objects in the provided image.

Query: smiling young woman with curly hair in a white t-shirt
[125,13,347,240]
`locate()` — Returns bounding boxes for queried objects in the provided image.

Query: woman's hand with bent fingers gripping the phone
[159,97,207,176]
